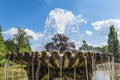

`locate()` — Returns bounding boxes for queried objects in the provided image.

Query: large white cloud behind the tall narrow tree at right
[92,19,120,39]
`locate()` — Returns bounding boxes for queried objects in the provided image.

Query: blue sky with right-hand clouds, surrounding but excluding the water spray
[0,0,120,50]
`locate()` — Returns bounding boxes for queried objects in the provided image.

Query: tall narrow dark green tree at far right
[108,25,120,62]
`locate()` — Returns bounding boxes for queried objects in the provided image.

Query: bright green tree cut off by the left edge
[0,26,7,64]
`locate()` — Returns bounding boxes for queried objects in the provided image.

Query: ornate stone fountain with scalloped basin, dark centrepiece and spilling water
[4,34,114,80]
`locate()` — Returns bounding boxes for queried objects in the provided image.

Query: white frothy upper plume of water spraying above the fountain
[45,8,86,33]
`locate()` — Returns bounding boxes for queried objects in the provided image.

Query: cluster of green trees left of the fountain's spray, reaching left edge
[0,27,32,64]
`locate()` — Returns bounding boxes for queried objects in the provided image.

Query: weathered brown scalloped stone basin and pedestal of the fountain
[8,50,113,80]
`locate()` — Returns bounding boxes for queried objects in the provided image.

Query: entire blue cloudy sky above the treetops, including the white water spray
[0,0,120,50]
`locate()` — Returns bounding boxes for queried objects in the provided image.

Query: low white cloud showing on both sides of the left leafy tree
[3,27,43,40]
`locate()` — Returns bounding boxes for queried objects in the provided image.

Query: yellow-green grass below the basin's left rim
[0,64,27,80]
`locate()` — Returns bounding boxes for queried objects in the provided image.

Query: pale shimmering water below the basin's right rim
[92,54,114,80]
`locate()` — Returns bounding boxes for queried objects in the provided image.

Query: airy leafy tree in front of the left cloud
[14,27,32,52]
